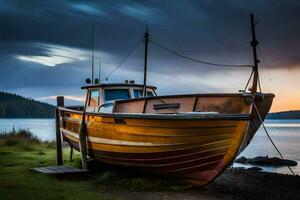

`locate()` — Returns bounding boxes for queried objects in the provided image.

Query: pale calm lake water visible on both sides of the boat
[0,119,300,175]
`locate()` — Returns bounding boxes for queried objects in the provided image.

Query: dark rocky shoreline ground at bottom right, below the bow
[124,168,300,200]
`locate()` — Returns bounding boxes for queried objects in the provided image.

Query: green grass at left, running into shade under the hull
[0,130,183,200]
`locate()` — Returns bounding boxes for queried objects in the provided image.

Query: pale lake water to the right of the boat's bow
[234,120,300,175]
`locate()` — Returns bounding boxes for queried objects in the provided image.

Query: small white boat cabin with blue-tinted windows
[82,81,157,113]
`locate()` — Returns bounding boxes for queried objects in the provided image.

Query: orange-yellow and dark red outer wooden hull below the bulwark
[61,93,274,186]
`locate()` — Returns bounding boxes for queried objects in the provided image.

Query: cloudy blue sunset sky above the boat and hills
[0,0,300,112]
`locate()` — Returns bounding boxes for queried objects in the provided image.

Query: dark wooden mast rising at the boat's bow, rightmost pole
[250,14,259,94]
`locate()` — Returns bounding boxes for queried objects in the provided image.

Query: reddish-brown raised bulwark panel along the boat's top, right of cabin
[113,93,252,114]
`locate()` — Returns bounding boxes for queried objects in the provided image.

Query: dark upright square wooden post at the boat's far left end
[55,96,64,165]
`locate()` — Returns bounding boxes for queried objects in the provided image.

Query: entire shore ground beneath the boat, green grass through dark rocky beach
[0,130,300,200]
